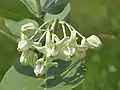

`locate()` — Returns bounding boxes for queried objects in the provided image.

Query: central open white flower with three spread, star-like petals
[33,30,69,58]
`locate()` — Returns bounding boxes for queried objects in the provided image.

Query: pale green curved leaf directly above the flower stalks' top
[44,3,71,21]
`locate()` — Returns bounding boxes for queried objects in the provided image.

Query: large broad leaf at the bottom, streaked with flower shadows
[0,60,85,90]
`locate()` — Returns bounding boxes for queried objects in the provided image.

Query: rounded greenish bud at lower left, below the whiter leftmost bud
[20,50,38,65]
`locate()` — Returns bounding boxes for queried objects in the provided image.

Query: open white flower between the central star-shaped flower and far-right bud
[63,30,88,60]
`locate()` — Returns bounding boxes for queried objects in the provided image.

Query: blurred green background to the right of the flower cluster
[71,0,120,90]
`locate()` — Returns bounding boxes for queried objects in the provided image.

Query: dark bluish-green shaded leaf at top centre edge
[40,0,69,14]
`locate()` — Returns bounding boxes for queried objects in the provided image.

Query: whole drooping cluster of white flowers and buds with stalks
[17,19,102,75]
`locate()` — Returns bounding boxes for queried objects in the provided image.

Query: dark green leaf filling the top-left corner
[0,0,36,21]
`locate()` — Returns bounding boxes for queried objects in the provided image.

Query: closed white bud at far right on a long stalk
[86,35,102,49]
